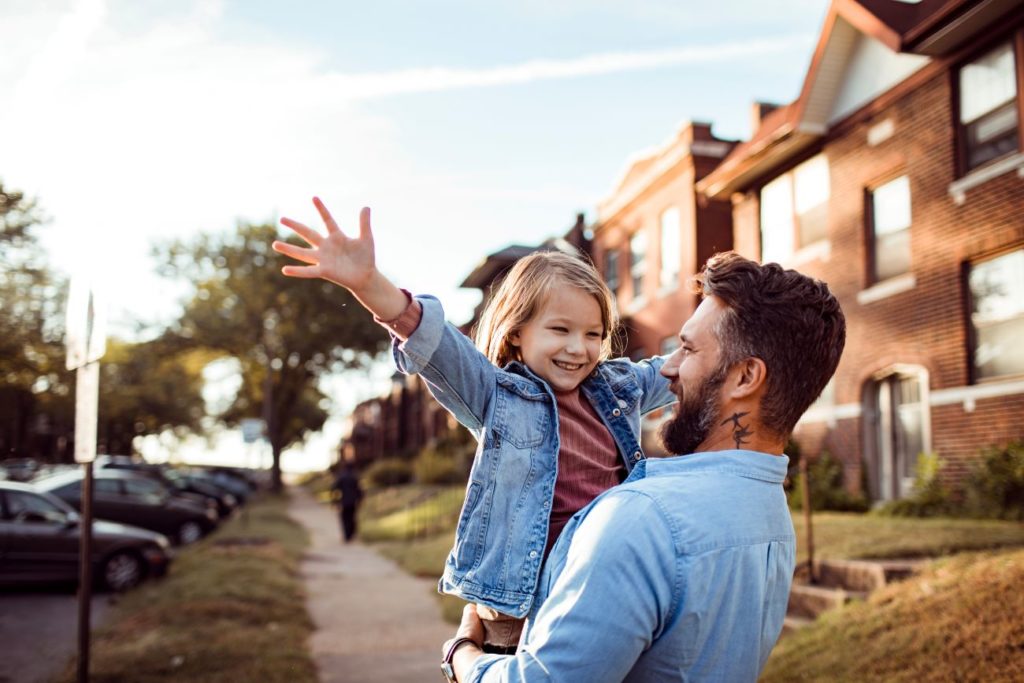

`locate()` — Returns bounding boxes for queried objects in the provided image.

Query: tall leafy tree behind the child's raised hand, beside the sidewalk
[156,224,387,487]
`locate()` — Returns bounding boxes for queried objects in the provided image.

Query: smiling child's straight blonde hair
[474,251,618,368]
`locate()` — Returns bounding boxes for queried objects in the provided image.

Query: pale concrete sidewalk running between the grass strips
[289,486,455,683]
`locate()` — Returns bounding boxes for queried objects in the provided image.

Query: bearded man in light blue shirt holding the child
[442,253,846,683]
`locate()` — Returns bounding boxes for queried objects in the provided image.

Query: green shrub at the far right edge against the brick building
[964,441,1024,521]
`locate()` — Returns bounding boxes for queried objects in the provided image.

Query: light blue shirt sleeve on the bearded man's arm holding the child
[467,493,679,683]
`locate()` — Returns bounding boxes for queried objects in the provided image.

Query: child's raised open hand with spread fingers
[271,197,377,293]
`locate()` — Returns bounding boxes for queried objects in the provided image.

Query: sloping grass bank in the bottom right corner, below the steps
[762,550,1024,683]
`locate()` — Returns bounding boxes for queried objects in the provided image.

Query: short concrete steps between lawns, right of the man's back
[782,560,923,635]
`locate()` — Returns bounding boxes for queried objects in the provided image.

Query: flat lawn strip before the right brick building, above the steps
[793,512,1024,561]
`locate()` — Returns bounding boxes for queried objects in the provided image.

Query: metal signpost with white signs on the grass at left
[67,279,106,683]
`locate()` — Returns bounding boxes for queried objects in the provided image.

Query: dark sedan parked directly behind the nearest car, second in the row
[34,469,217,545]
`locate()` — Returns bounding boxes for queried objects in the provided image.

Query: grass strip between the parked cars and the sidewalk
[51,497,316,683]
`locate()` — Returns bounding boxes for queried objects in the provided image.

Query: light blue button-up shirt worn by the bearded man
[468,451,796,683]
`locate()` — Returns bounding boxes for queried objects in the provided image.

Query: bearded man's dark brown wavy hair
[693,252,846,438]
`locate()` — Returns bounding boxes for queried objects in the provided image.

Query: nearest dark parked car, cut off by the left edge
[0,481,172,591]
